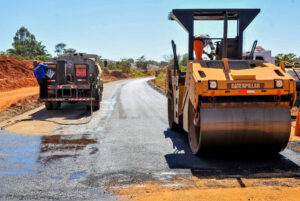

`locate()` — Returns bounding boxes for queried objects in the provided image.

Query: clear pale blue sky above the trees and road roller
[0,0,300,61]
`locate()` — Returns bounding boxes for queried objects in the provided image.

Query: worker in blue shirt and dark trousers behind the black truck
[33,61,48,98]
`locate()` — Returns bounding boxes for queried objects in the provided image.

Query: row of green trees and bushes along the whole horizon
[0,26,300,66]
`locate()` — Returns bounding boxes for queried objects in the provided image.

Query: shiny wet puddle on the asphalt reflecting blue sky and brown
[0,130,99,176]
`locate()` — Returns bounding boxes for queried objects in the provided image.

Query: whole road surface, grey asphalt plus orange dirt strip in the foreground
[0,78,300,200]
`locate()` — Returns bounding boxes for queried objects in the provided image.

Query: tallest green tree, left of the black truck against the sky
[7,27,51,59]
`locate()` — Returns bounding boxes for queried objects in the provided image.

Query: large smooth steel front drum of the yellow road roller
[188,103,291,154]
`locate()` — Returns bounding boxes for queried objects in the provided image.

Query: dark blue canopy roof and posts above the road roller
[169,9,260,60]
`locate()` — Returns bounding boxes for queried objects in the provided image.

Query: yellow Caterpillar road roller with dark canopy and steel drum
[166,9,296,154]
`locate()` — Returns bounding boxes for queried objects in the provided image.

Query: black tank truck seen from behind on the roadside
[42,53,103,110]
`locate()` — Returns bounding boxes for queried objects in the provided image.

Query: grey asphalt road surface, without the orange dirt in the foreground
[0,78,300,200]
